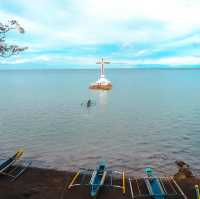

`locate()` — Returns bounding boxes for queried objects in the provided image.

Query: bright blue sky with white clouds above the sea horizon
[0,0,200,69]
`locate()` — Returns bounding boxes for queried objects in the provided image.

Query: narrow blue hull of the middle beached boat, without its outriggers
[89,162,107,197]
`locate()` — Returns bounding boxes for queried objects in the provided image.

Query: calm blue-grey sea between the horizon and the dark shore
[0,69,200,175]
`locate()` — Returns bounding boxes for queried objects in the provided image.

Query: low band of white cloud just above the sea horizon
[0,54,200,68]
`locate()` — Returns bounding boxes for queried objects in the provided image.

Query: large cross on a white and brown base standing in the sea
[89,58,112,90]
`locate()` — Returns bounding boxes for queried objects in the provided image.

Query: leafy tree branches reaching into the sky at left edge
[0,20,28,58]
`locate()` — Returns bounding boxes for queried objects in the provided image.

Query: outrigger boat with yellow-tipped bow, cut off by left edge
[0,149,32,181]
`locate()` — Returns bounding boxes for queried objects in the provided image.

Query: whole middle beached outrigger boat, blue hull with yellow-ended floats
[67,161,126,197]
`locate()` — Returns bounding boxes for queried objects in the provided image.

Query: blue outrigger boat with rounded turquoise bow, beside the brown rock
[129,168,187,199]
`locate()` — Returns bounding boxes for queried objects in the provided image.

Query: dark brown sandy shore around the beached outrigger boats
[0,168,200,199]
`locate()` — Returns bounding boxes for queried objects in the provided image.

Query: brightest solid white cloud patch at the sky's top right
[78,0,200,28]
